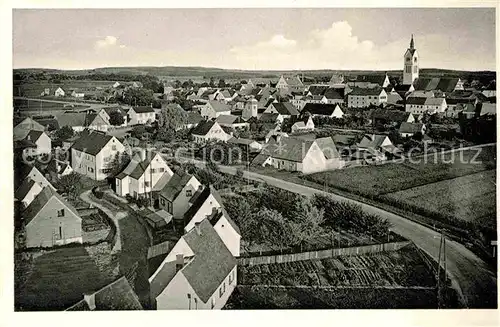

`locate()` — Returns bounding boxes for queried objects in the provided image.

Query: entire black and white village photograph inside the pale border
[7,3,498,318]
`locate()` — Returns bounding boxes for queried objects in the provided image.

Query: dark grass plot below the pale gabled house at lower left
[15,246,112,311]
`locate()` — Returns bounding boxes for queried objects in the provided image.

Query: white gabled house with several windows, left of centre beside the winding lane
[115,149,174,199]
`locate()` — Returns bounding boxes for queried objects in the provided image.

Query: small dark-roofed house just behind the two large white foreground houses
[159,173,202,221]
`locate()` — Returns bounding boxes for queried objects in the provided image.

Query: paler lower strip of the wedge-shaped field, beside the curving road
[385,170,496,221]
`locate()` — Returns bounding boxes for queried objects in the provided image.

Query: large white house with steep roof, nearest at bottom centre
[149,219,237,310]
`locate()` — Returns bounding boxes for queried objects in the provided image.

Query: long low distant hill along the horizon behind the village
[14,66,496,79]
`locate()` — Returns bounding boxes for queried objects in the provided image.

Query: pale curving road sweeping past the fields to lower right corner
[219,166,497,308]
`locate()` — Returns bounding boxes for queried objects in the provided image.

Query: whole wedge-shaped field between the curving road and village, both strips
[304,147,496,223]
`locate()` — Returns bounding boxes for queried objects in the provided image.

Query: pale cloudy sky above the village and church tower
[13,8,496,70]
